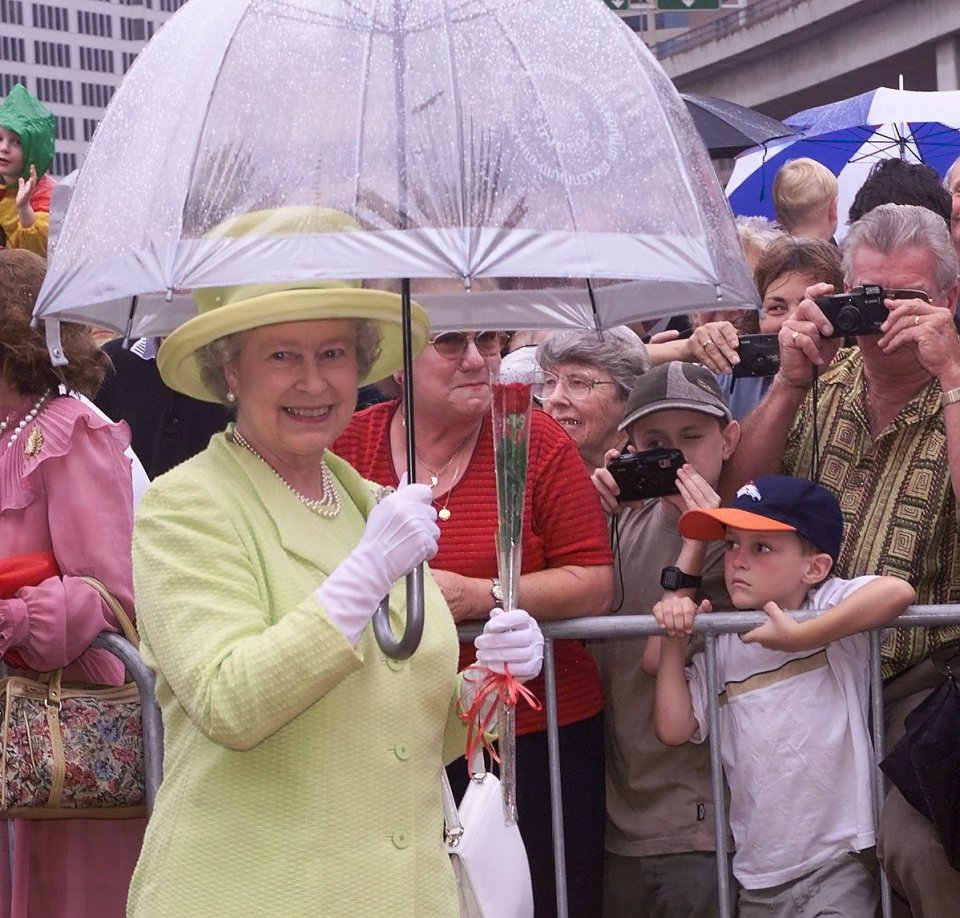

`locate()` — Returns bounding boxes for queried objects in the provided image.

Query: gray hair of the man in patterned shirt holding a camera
[843,204,957,294]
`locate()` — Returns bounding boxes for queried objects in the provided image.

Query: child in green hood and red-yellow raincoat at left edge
[0,83,57,258]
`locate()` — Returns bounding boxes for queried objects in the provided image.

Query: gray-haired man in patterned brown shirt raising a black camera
[723,204,960,918]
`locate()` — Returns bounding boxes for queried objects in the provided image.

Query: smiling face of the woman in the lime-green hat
[224,319,358,483]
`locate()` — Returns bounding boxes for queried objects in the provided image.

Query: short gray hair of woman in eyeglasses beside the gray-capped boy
[537,325,650,401]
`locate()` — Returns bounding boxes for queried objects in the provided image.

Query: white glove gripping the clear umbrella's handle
[316,476,440,644]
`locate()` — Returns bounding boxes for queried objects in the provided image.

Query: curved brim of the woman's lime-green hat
[157,287,430,402]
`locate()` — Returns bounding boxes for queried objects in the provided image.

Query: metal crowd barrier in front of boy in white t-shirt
[457,605,960,918]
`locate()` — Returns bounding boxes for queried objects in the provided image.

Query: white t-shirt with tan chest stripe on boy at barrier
[687,577,876,889]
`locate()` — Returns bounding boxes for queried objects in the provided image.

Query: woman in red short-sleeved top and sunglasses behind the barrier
[332,331,612,918]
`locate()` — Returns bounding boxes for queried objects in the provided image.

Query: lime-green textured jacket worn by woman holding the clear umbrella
[127,434,466,918]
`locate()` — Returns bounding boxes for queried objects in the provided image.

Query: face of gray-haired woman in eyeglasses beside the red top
[543,361,626,469]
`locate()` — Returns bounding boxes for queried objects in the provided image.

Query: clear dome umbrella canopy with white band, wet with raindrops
[36,0,756,334]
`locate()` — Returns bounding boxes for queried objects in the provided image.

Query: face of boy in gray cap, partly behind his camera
[628,408,740,510]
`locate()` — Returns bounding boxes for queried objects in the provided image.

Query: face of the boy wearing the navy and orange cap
[723,526,831,609]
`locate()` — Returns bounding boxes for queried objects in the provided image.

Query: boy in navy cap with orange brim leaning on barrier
[654,475,915,918]
